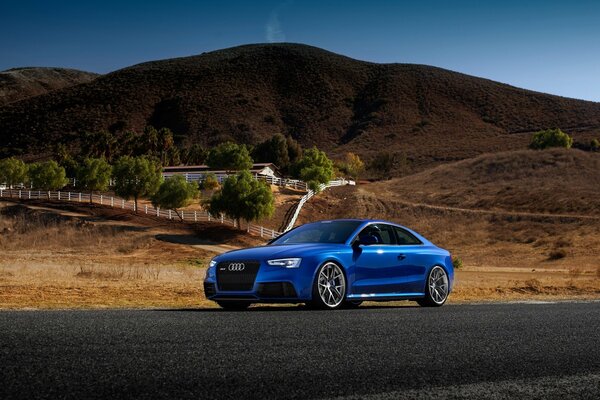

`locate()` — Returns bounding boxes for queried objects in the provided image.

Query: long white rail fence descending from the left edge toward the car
[0,189,281,238]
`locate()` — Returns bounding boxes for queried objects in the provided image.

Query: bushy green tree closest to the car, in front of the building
[208,171,275,227]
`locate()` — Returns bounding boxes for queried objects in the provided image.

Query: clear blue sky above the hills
[0,0,600,101]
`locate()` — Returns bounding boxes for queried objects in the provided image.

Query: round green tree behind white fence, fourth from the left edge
[113,156,162,213]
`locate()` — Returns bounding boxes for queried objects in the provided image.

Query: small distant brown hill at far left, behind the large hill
[0,67,98,107]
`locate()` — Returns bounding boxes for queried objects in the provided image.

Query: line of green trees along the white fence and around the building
[0,139,352,226]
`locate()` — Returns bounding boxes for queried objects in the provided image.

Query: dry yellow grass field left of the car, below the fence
[0,206,216,309]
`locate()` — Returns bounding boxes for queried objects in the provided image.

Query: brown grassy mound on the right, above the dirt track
[369,149,600,217]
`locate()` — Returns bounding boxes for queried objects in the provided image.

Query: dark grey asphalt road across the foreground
[0,302,600,400]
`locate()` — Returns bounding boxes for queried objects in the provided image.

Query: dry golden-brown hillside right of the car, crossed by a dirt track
[298,150,600,276]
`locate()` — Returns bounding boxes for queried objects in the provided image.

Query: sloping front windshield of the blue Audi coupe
[272,221,361,244]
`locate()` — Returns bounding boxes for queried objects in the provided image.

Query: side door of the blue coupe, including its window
[352,224,402,295]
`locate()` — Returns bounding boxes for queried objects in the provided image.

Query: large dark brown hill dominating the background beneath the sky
[0,44,600,167]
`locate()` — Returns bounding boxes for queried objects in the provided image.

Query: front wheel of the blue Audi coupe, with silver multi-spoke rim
[311,261,346,310]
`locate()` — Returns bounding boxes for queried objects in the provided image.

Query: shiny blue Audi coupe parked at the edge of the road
[204,219,454,309]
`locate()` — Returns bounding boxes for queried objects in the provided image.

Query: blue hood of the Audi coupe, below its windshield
[214,243,347,262]
